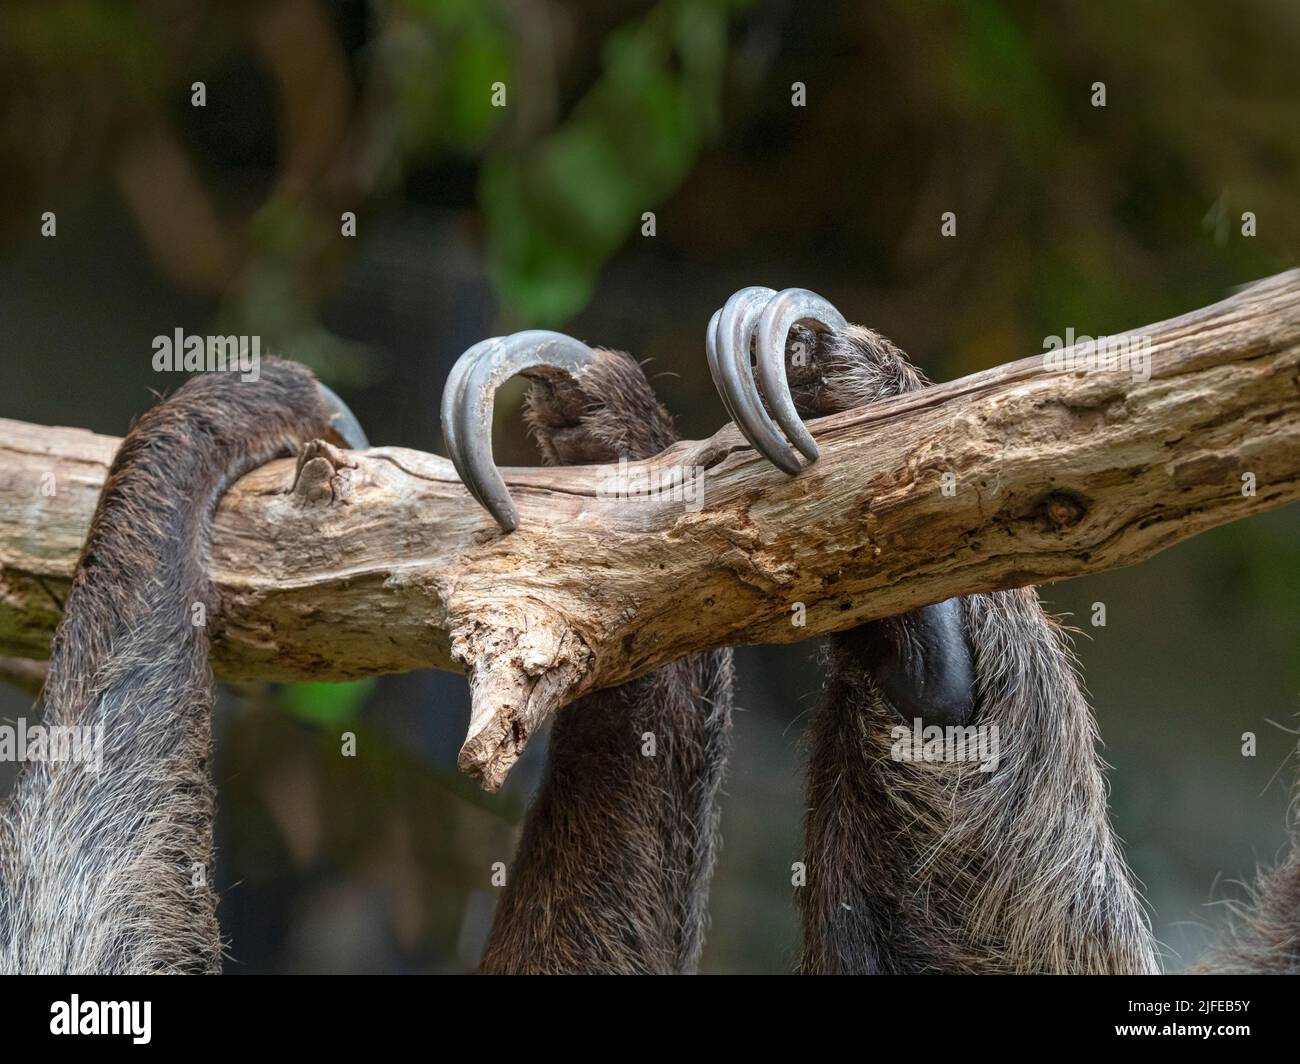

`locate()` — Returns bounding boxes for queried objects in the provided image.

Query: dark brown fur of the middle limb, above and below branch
[482,351,731,973]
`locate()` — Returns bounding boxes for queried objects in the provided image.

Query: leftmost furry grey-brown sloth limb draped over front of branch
[0,359,353,973]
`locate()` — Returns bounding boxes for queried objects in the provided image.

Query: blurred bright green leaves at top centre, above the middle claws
[480,0,744,326]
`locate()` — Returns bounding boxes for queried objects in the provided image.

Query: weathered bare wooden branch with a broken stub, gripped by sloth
[0,272,1300,788]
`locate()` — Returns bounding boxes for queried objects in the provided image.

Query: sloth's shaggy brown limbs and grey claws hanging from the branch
[0,327,1300,973]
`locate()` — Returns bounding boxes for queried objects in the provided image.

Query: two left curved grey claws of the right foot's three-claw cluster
[705,286,800,475]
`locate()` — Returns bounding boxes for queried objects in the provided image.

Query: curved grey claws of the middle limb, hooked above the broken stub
[442,329,595,532]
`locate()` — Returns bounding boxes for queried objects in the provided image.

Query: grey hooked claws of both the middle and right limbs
[431,287,848,532]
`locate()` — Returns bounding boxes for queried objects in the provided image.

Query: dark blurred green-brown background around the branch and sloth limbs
[0,0,1300,972]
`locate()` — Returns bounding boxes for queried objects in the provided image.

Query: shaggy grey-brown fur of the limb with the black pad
[790,328,1157,973]
